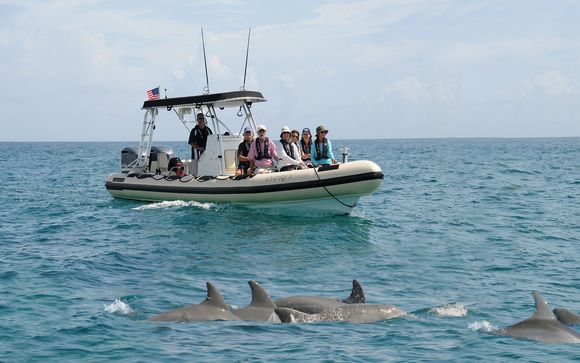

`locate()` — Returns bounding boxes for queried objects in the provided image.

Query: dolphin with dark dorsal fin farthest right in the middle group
[274,280,365,314]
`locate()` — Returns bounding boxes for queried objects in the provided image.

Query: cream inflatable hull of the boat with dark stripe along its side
[105,160,384,214]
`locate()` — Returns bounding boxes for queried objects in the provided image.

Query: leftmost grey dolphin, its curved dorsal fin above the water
[149,282,240,321]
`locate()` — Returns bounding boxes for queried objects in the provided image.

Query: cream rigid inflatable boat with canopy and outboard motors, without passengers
[105,91,383,214]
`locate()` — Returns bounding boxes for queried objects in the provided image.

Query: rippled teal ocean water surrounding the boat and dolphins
[0,138,580,362]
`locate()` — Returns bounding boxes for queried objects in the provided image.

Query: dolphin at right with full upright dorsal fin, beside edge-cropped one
[499,291,580,344]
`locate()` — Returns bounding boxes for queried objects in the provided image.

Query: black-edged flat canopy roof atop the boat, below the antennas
[143,91,266,108]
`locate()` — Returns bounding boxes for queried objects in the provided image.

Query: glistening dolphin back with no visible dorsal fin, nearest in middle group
[276,304,407,323]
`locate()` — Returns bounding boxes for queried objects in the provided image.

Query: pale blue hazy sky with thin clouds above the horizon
[0,0,580,142]
